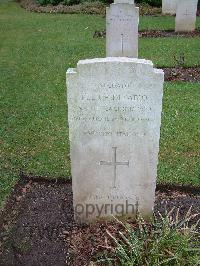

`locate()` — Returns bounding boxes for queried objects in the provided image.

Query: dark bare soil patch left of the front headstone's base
[0,176,73,266]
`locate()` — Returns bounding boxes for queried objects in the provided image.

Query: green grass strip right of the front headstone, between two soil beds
[158,83,200,185]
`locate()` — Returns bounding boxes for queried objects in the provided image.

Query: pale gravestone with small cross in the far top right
[176,0,198,32]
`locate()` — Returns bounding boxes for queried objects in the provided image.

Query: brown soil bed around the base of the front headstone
[0,176,200,266]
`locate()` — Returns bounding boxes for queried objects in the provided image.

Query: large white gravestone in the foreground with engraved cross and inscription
[67,57,164,222]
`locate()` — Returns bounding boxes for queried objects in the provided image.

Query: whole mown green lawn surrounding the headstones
[0,1,200,207]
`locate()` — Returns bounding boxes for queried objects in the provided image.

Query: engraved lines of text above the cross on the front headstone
[70,83,155,137]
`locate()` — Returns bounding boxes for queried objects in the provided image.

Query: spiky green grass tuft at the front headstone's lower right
[97,208,200,266]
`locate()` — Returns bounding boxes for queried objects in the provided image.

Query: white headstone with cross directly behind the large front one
[106,3,139,58]
